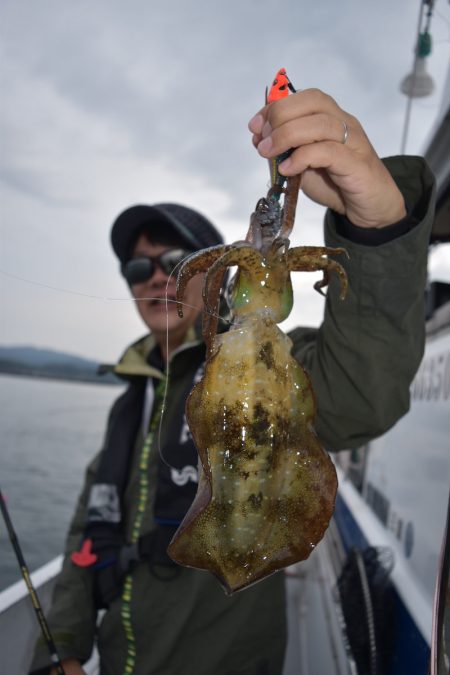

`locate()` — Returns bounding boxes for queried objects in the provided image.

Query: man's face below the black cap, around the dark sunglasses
[127,234,203,349]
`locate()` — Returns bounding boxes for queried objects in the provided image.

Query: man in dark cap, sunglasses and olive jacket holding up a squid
[33,90,433,675]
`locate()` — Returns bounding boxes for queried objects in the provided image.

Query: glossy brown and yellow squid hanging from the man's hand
[168,69,347,594]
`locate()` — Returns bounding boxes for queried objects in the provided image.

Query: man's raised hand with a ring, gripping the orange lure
[249,89,406,227]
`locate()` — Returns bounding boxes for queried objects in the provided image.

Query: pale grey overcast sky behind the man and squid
[0,0,450,361]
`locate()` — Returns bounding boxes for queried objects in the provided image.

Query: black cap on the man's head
[111,204,223,264]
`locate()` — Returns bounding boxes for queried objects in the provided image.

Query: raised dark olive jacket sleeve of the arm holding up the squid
[290,157,435,451]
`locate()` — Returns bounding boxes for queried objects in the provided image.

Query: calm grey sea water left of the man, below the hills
[0,375,123,590]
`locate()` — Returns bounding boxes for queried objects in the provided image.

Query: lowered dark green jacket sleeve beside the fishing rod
[30,456,99,675]
